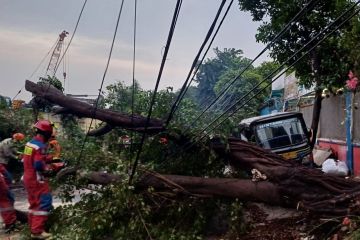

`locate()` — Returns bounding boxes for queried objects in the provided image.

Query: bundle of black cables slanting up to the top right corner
[166,0,360,161]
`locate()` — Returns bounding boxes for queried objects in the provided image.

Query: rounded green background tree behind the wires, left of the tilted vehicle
[190,48,278,132]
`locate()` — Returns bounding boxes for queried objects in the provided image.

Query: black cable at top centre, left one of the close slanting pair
[166,0,226,126]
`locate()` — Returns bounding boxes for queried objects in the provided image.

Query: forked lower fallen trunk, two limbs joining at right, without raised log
[57,138,360,215]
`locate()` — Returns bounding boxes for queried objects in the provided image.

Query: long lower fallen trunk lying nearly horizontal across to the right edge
[59,160,360,216]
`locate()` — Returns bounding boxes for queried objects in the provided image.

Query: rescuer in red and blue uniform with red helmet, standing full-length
[23,120,53,239]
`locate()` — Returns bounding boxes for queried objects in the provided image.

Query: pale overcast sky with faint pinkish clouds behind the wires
[0,0,266,100]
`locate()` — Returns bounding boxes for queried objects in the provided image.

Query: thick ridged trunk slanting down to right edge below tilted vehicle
[215,138,360,215]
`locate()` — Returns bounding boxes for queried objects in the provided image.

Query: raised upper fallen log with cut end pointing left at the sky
[25,80,164,133]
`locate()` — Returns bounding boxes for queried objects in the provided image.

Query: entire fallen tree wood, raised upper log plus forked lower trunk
[25,81,360,215]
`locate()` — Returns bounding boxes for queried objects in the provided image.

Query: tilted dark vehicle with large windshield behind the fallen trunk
[237,112,312,163]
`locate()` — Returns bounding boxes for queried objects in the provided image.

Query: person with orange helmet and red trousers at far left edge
[0,133,25,233]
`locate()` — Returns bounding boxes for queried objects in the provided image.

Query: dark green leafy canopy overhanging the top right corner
[239,0,358,88]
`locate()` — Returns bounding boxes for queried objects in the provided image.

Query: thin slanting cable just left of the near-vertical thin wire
[76,0,124,165]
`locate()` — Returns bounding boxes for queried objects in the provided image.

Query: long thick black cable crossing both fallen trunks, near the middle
[129,0,182,184]
